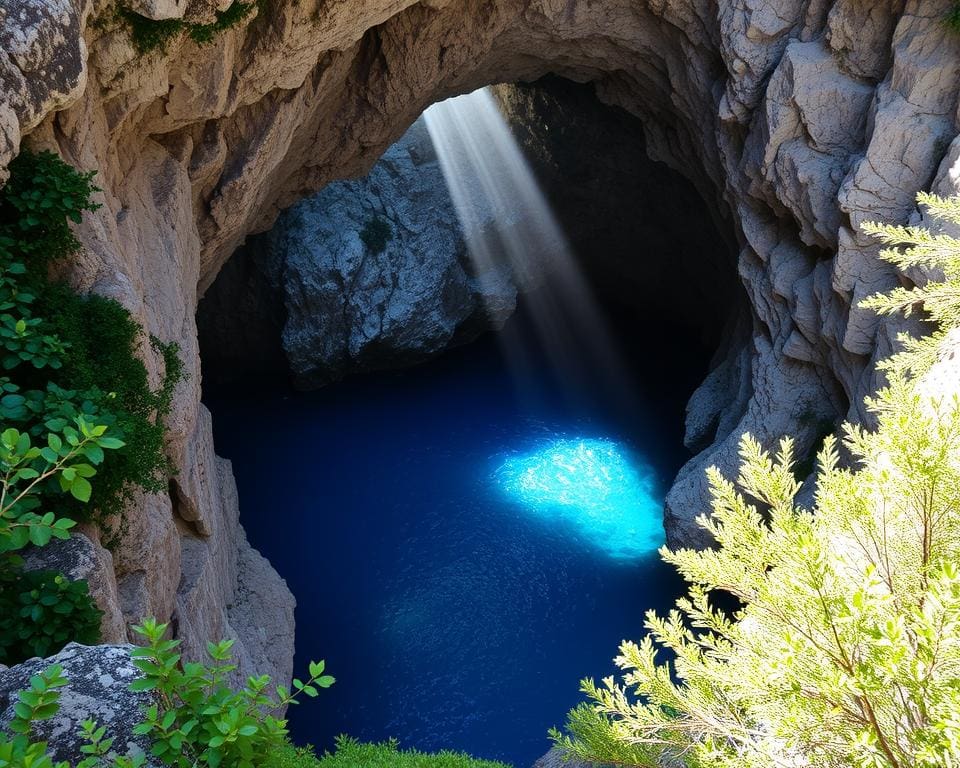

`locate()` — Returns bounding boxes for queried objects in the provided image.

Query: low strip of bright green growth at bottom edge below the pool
[265,736,508,768]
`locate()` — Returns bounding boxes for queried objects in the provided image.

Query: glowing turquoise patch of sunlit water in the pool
[496,439,664,560]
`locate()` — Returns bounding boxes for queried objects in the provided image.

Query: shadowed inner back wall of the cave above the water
[197,77,746,389]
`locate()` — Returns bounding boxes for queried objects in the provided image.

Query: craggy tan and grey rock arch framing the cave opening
[0,0,960,675]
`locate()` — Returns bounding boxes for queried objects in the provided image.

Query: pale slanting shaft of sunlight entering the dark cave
[424,88,632,412]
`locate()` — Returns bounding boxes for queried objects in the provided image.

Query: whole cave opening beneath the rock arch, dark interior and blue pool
[198,79,746,766]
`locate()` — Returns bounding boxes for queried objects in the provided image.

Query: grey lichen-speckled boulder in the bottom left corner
[0,643,151,765]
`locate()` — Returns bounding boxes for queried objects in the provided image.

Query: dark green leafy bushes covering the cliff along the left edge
[0,152,183,663]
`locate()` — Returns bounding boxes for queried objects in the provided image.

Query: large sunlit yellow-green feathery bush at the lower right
[553,195,960,768]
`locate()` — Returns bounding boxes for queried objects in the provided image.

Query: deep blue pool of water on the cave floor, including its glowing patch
[208,304,702,767]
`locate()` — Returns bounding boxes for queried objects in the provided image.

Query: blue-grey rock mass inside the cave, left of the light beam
[198,120,517,389]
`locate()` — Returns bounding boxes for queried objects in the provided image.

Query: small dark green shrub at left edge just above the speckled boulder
[0,570,103,665]
